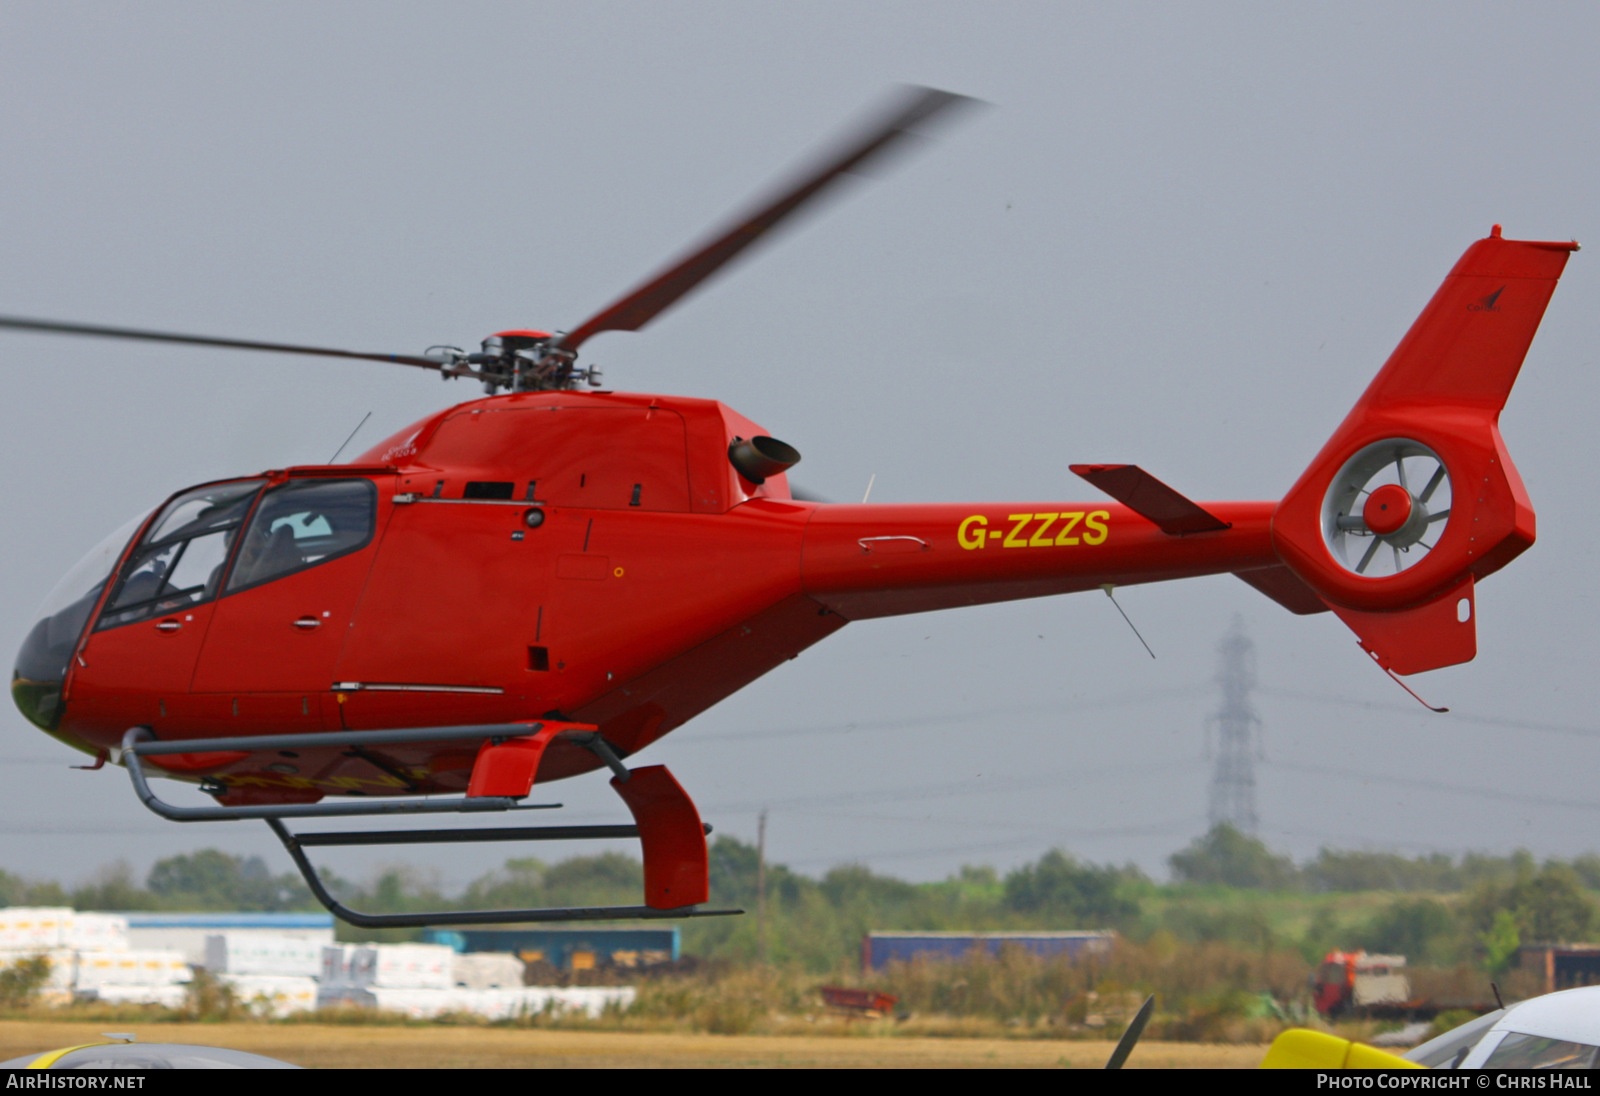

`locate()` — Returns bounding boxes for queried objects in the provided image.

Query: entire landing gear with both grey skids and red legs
[122,723,744,928]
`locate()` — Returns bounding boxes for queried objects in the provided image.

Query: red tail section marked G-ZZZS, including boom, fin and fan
[800,227,1578,674]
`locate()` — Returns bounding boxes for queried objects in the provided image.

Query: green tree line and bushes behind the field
[0,824,1600,970]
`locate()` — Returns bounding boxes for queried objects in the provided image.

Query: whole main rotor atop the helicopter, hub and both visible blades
[0,88,976,394]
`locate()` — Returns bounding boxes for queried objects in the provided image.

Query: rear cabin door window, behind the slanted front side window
[227,480,378,594]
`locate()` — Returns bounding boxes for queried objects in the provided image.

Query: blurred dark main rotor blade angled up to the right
[557,88,978,350]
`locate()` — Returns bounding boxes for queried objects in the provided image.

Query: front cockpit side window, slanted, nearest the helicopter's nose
[94,480,262,632]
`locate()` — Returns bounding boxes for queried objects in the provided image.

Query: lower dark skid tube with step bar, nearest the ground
[267,818,744,928]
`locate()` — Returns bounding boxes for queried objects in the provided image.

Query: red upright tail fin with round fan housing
[1272,226,1578,674]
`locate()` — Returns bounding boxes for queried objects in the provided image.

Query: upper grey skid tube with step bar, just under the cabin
[122,723,560,822]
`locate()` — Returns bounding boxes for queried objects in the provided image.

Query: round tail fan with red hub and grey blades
[1323,438,1451,578]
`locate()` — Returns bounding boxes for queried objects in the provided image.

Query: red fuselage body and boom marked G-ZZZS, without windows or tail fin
[43,392,1277,800]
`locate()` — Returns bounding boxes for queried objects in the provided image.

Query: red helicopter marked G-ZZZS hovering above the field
[0,88,1578,926]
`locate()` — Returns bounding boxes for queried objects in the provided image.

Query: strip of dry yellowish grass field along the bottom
[0,1021,1266,1069]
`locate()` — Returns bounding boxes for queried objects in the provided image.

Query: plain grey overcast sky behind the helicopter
[0,0,1600,886]
